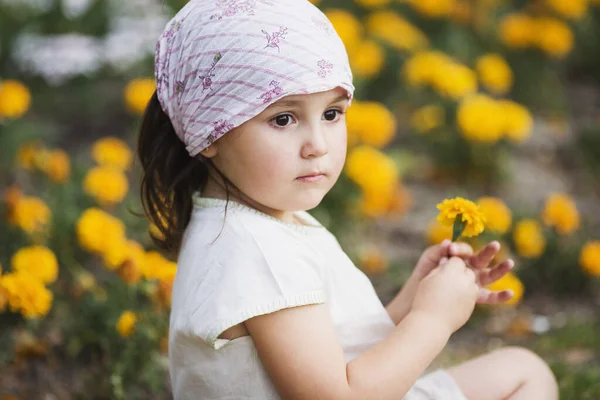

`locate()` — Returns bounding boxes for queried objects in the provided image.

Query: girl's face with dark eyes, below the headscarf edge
[202,88,348,219]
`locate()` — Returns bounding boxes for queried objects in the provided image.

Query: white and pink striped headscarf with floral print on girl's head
[155,0,354,156]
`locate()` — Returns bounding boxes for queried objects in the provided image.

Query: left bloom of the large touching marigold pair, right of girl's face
[457,94,505,143]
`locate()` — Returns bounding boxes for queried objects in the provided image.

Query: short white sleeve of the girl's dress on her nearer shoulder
[190,212,326,349]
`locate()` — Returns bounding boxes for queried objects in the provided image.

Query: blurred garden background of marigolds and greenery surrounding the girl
[0,0,600,400]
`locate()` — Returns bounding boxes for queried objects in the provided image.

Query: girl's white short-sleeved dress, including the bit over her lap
[169,195,466,400]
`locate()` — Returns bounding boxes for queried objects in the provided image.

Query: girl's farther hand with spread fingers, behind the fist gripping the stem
[413,240,515,304]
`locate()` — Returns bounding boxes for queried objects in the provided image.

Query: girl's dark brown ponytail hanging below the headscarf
[137,92,231,256]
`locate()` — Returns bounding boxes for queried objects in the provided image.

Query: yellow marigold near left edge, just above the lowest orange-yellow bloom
[11,246,58,284]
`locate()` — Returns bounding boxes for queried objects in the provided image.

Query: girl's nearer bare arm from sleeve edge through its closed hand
[245,257,479,400]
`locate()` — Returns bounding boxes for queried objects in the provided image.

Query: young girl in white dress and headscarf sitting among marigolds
[138,0,557,400]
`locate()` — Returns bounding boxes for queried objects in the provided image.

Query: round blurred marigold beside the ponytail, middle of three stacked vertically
[83,167,129,205]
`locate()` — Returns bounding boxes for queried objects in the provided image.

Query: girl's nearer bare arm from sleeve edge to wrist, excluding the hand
[245,304,452,400]
